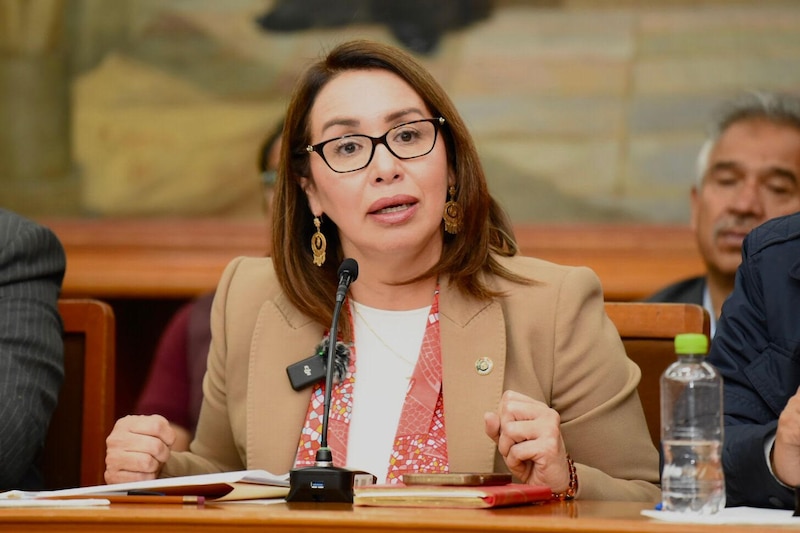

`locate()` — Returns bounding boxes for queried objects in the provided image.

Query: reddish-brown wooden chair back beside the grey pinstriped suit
[40,298,116,489]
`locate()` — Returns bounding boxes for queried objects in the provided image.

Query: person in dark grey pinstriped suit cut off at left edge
[0,209,66,490]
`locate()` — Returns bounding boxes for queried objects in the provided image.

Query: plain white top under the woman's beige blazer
[347,300,430,483]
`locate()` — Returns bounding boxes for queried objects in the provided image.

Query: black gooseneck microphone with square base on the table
[286,258,373,503]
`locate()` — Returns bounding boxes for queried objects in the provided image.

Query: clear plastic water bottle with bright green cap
[661,333,725,514]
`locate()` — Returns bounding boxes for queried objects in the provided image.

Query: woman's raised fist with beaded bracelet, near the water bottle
[484,391,569,493]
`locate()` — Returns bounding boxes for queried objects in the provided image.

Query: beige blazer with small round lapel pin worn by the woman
[162,252,660,501]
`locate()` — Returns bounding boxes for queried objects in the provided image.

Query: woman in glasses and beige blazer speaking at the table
[106,41,660,501]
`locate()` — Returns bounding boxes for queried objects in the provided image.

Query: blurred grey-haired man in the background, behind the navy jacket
[647,92,800,337]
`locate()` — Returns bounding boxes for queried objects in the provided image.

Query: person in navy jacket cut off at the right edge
[708,214,800,508]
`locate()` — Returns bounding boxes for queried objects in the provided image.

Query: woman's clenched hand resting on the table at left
[105,415,175,484]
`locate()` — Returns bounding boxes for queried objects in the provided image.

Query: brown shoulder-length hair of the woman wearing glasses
[272,40,528,339]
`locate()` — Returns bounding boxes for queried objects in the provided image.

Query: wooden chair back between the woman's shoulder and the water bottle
[605,302,711,447]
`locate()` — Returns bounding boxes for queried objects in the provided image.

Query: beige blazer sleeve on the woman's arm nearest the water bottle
[551,268,661,501]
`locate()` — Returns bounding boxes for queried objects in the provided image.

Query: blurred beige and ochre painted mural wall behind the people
[0,0,800,222]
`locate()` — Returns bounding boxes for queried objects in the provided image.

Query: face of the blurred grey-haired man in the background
[692,119,800,275]
